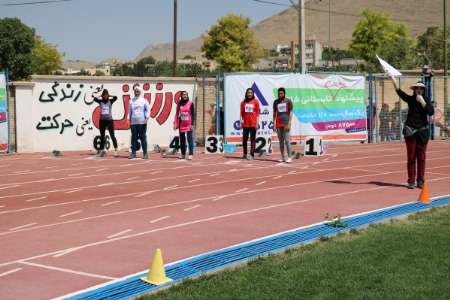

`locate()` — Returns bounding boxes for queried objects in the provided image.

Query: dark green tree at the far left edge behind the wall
[0,18,34,80]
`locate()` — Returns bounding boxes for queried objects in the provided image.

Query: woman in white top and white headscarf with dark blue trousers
[128,86,150,159]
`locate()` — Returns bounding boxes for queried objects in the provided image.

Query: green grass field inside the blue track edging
[139,207,450,300]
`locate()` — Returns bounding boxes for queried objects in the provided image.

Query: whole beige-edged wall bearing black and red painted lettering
[14,76,195,152]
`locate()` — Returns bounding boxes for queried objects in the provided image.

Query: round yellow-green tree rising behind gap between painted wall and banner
[202,14,260,72]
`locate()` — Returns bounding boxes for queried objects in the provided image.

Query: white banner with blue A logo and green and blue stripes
[225,73,367,143]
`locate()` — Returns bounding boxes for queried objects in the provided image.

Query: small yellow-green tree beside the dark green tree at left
[31,35,63,75]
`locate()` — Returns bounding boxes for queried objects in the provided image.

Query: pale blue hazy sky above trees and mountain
[0,0,289,61]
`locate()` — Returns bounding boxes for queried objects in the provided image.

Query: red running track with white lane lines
[0,141,450,299]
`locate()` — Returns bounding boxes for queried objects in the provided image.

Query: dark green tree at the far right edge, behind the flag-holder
[416,27,450,69]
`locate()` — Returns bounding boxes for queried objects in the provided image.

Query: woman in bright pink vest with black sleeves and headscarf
[173,91,195,160]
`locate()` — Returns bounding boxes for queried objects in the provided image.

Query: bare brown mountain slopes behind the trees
[136,0,442,60]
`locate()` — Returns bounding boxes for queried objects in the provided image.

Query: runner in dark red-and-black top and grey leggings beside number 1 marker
[273,87,293,163]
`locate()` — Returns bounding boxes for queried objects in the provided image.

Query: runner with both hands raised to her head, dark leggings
[94,89,119,157]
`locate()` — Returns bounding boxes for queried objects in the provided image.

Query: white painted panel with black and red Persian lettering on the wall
[30,79,195,151]
